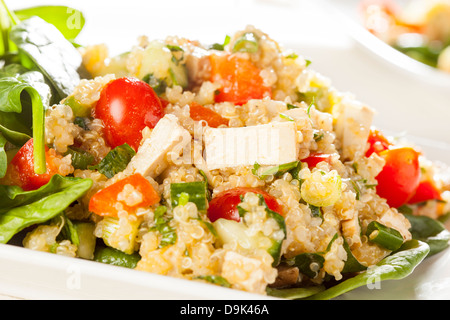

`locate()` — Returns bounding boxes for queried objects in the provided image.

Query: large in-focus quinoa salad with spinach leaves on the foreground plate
[0,3,450,299]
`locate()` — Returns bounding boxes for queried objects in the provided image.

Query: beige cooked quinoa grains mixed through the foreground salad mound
[2,26,450,294]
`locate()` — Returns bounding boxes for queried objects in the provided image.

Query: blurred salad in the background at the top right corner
[360,0,450,72]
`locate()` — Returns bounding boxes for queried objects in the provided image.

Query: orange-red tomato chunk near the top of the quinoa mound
[210,54,272,105]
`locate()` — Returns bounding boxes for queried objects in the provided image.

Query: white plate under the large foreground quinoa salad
[0,0,450,300]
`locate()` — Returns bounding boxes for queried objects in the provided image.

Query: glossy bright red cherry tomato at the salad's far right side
[376,147,420,208]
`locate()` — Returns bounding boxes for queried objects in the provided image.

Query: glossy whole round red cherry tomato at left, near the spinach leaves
[94,77,164,150]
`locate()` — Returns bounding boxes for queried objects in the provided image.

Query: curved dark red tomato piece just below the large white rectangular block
[208,187,283,222]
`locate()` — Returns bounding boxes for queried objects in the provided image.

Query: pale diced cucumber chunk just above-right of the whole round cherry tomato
[137,40,188,88]
